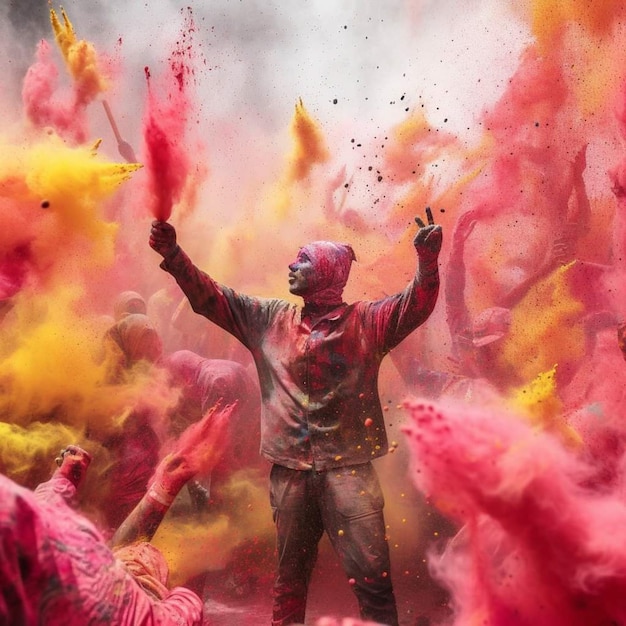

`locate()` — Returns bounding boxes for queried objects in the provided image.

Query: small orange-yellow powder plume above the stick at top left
[50,9,107,102]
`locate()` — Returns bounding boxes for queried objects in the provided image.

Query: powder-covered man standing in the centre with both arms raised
[150,211,442,626]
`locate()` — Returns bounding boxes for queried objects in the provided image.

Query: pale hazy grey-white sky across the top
[5,0,530,146]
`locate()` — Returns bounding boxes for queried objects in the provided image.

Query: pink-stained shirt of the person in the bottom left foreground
[0,474,202,626]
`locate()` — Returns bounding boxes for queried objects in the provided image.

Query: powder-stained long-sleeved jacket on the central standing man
[161,249,439,471]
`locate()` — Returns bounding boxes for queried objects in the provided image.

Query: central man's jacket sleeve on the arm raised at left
[161,248,270,348]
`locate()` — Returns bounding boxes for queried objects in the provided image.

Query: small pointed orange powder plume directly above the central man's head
[288,99,329,182]
